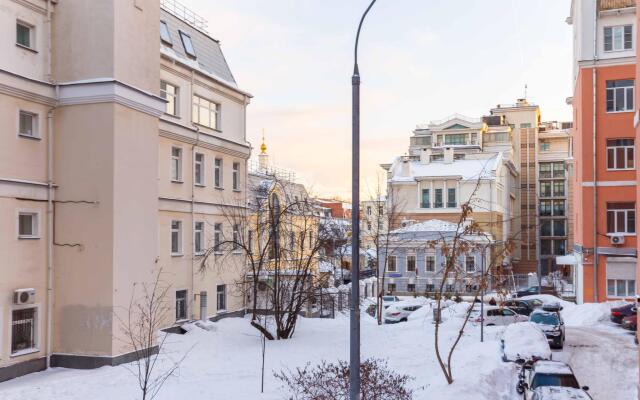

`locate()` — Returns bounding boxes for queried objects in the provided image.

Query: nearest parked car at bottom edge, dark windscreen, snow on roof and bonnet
[517,360,589,400]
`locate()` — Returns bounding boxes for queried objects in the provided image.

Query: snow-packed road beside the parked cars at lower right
[553,324,638,400]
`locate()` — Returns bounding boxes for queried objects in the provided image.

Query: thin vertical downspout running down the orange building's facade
[591,0,598,303]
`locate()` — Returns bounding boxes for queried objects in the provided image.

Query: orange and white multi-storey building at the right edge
[567,0,637,302]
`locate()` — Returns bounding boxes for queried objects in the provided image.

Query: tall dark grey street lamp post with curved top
[349,0,376,400]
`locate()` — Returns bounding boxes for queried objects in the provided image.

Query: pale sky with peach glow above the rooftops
[182,0,572,198]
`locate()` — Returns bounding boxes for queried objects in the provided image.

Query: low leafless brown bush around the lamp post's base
[274,358,413,400]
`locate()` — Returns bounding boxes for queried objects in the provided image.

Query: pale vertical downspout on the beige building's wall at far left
[46,0,60,368]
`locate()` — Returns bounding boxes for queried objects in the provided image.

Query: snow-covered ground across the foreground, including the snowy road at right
[0,305,638,400]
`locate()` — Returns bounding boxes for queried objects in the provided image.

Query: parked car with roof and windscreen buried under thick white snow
[501,322,552,362]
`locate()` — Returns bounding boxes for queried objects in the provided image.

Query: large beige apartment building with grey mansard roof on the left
[0,0,251,381]
